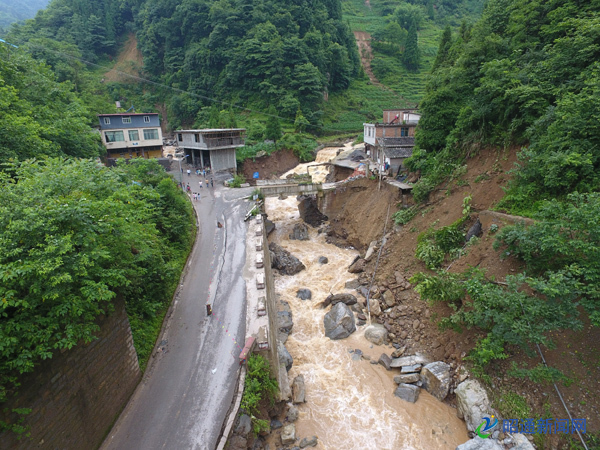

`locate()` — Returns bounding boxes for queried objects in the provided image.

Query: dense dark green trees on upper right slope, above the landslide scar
[410,0,600,212]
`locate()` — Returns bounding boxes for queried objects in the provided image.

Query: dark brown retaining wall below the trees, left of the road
[0,301,141,450]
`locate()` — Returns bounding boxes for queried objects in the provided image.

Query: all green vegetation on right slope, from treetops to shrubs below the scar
[406,0,600,384]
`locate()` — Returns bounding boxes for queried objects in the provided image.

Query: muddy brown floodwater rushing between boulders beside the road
[265,156,468,450]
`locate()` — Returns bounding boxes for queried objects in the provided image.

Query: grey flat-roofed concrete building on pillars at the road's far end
[175,128,246,173]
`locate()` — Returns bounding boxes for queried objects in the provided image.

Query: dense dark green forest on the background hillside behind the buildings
[9,0,360,128]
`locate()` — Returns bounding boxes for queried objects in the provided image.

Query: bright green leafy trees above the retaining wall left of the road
[0,158,192,401]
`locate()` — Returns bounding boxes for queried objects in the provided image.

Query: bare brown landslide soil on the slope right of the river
[325,148,600,448]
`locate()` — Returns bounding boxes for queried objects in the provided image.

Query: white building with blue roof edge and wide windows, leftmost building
[98,113,162,159]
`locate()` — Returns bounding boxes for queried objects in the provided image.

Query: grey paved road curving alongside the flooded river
[101,175,253,450]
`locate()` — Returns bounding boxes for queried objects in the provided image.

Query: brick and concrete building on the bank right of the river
[363,109,421,175]
